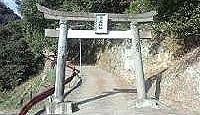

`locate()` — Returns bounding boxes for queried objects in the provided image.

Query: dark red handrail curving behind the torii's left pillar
[18,65,79,115]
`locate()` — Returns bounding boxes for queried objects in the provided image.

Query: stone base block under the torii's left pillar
[46,101,73,115]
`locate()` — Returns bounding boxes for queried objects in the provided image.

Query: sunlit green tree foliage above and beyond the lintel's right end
[127,0,200,53]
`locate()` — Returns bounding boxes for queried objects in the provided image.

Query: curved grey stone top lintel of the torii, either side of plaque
[37,4,156,22]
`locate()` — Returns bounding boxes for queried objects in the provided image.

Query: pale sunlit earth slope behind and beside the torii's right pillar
[97,40,200,113]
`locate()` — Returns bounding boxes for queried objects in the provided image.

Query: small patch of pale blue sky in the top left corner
[0,0,19,15]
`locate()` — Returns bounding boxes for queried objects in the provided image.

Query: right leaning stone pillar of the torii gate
[131,22,146,101]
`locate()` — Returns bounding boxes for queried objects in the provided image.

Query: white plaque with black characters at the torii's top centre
[95,13,108,34]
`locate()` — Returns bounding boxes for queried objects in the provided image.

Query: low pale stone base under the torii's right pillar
[136,99,159,109]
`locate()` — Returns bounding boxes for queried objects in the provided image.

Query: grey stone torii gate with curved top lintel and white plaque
[37,4,156,113]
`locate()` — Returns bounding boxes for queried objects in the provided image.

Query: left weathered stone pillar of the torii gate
[54,20,67,103]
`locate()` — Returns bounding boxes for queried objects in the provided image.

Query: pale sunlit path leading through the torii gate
[65,66,188,115]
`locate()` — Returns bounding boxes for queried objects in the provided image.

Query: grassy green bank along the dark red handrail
[0,69,55,111]
